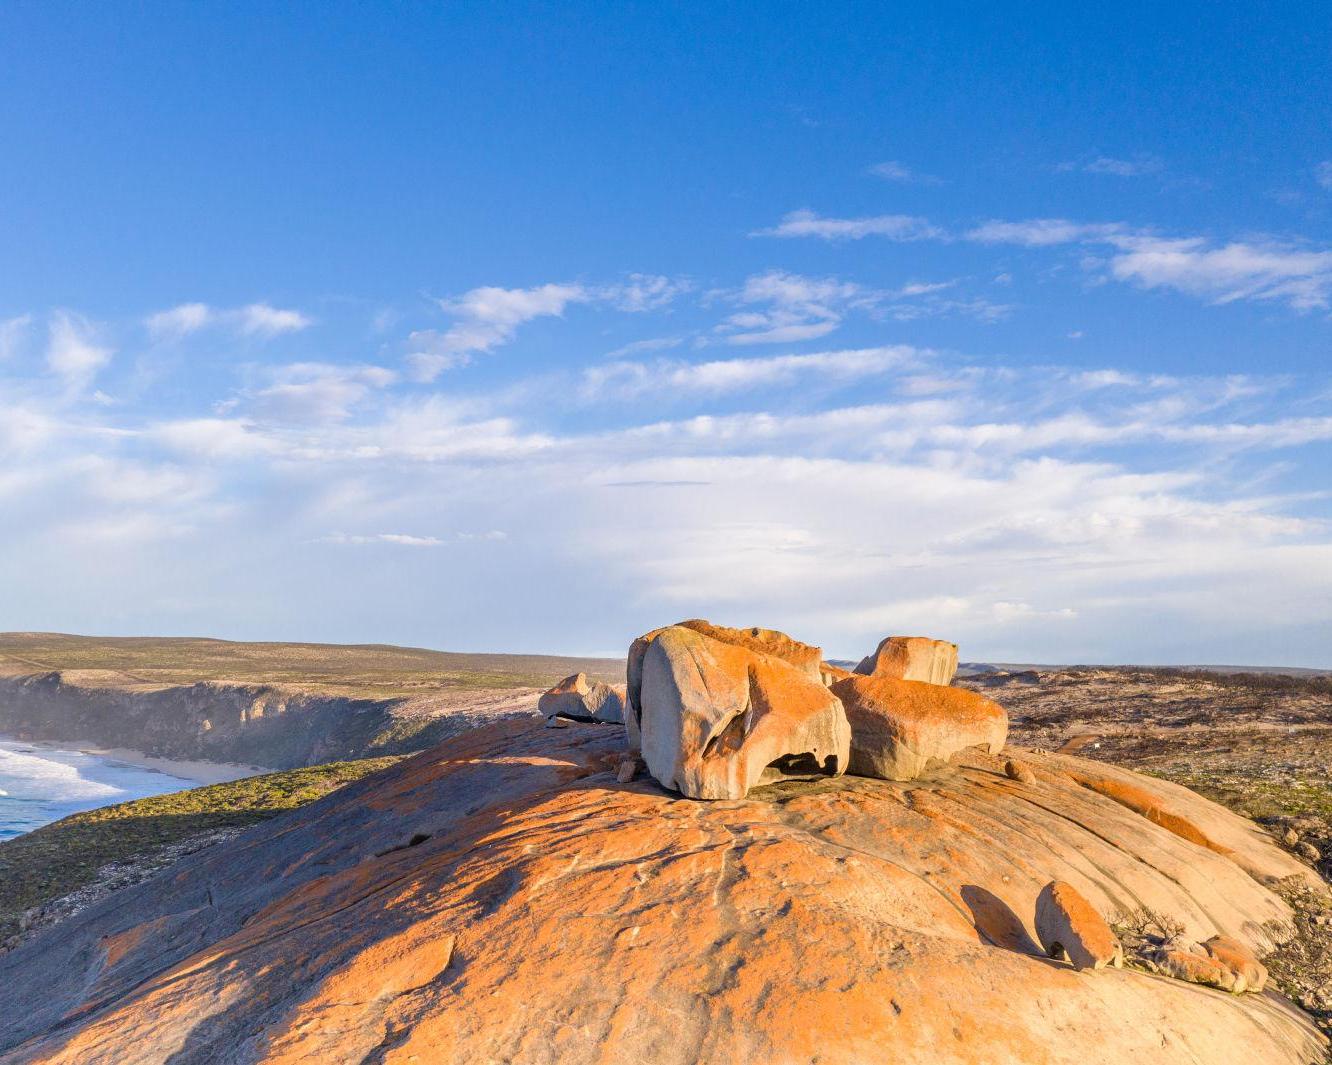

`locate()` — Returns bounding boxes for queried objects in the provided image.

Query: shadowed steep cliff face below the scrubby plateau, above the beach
[0,671,537,769]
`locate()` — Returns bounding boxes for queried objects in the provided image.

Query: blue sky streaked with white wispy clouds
[0,3,1332,666]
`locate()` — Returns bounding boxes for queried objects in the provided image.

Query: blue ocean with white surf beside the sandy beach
[0,739,198,840]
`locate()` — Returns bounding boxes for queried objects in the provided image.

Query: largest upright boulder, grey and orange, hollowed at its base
[630,623,851,799]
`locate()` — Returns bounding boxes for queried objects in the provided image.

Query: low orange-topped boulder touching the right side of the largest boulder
[831,674,1008,780]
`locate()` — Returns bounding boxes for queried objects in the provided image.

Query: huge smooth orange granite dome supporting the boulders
[0,722,1325,1065]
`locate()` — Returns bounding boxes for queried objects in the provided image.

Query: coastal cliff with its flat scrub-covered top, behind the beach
[0,632,615,769]
